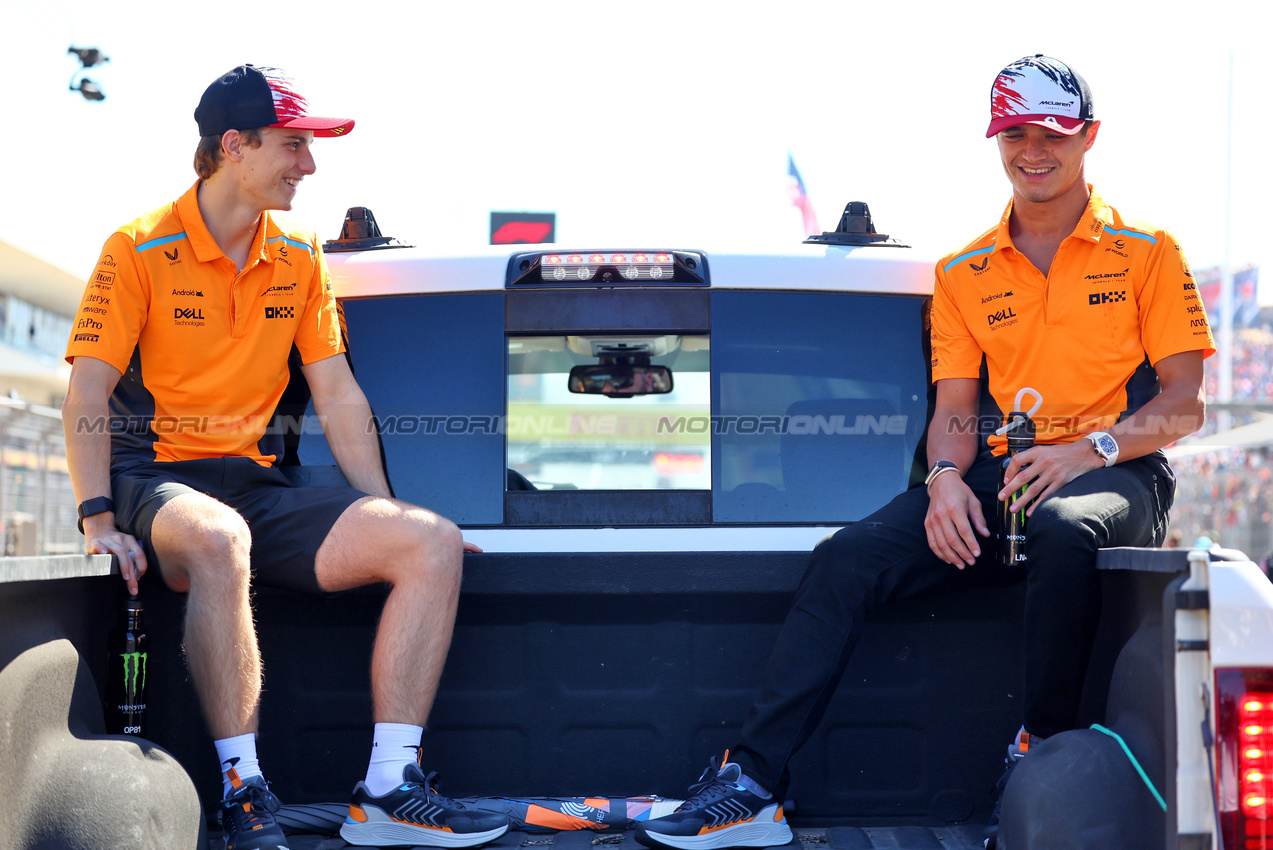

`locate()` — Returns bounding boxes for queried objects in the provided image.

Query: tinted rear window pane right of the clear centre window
[712,291,927,523]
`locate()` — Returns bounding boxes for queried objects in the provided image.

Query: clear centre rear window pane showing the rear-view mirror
[508,333,712,490]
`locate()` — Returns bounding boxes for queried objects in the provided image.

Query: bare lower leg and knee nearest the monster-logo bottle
[150,492,261,738]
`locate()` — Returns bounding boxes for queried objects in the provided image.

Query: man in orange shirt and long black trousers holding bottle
[637,55,1214,850]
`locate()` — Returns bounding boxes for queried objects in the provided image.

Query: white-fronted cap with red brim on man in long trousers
[985,53,1095,139]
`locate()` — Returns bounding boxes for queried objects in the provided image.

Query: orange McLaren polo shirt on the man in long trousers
[932,187,1216,454]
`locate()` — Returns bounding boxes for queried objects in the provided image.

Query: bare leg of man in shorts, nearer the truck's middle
[316,496,463,727]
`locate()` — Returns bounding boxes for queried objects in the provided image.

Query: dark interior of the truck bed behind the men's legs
[0,551,1184,850]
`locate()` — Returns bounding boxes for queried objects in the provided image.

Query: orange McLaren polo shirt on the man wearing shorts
[66,181,344,468]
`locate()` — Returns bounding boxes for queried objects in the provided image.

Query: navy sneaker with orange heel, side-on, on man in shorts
[340,765,508,847]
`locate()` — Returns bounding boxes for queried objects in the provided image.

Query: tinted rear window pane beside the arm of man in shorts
[300,293,505,524]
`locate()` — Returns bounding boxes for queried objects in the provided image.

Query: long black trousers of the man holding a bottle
[729,453,1175,794]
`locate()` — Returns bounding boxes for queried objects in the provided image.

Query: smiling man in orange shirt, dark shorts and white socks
[64,65,508,850]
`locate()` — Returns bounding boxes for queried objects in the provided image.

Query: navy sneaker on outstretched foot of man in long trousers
[637,753,792,850]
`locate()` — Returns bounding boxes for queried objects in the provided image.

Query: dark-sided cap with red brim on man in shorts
[195,65,354,136]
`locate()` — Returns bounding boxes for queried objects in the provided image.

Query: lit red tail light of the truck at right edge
[1216,669,1273,850]
